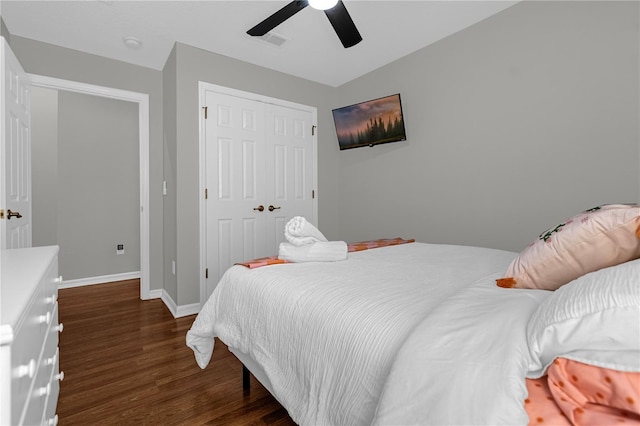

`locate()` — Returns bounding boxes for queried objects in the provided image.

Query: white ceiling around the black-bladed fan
[0,0,517,87]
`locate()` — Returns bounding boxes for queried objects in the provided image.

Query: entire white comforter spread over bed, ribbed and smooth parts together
[187,243,546,425]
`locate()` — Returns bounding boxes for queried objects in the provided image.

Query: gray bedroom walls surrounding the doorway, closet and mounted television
[6,1,640,305]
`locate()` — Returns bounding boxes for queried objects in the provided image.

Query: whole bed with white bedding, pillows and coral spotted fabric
[187,205,640,425]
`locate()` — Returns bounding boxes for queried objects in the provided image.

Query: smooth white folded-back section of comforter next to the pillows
[373,266,550,425]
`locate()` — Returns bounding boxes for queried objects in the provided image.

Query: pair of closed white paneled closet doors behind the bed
[202,86,315,302]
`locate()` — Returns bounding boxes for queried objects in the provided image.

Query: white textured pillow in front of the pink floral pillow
[527,259,640,378]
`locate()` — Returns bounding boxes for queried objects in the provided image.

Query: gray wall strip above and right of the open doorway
[11,36,164,291]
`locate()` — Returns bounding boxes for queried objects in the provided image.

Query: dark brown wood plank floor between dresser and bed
[58,280,295,426]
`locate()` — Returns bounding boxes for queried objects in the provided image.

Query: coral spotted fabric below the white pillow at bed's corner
[525,358,640,425]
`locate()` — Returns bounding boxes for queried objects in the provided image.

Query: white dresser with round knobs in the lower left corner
[0,246,64,426]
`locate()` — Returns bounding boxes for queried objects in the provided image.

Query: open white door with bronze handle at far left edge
[0,38,31,249]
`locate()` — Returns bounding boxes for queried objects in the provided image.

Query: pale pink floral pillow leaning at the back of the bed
[496,204,640,290]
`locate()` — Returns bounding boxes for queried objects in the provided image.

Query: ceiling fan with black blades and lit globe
[247,0,362,48]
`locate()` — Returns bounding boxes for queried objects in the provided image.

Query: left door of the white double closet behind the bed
[205,92,267,294]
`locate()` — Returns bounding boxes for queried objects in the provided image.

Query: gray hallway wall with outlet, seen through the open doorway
[58,91,140,280]
